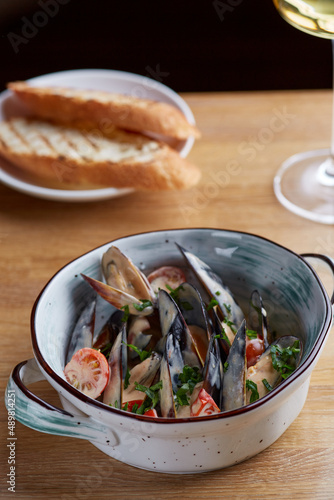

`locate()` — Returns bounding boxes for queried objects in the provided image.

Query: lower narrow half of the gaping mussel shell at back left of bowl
[81,274,153,316]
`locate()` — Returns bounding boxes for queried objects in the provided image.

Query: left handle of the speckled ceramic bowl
[5,359,119,446]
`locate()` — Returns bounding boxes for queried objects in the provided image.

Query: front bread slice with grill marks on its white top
[0,118,200,191]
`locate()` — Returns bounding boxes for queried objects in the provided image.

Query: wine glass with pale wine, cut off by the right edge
[273,0,334,224]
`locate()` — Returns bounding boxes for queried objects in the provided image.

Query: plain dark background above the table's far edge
[0,0,332,92]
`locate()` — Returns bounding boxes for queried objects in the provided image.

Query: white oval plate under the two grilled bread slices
[0,69,195,201]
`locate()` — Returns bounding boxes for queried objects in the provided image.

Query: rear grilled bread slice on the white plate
[8,82,200,140]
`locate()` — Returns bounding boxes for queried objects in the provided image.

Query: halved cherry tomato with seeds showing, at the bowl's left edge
[64,347,109,399]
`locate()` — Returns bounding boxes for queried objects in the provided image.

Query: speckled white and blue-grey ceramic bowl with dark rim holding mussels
[7,229,334,473]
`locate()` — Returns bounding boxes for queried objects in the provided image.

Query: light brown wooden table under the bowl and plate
[0,91,334,500]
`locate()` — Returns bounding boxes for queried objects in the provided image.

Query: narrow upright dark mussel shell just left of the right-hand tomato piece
[222,320,246,411]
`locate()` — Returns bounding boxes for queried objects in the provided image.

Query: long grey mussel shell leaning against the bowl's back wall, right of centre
[176,243,244,329]
